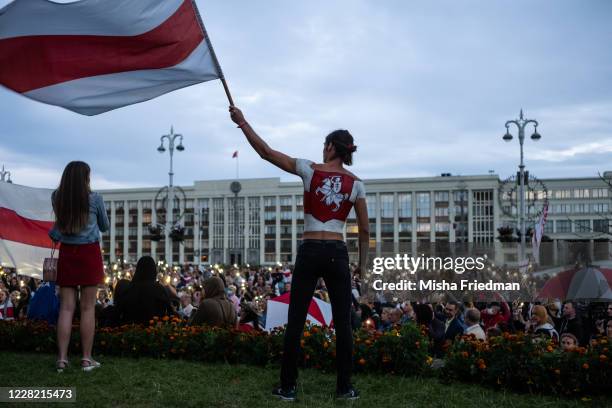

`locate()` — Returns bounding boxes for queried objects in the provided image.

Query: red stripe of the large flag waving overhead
[0,0,204,93]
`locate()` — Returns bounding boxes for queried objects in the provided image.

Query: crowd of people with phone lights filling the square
[0,262,612,356]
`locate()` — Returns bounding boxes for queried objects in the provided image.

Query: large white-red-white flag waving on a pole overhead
[0,0,224,115]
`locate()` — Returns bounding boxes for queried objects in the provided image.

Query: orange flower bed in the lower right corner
[443,333,612,396]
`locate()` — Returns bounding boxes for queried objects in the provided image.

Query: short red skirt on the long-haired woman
[55,242,104,286]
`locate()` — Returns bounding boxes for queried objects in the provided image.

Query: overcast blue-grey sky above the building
[0,0,612,189]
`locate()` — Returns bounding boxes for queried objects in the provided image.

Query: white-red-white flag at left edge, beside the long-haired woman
[0,182,54,279]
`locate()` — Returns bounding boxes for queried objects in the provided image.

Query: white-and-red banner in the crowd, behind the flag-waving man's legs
[266,292,332,331]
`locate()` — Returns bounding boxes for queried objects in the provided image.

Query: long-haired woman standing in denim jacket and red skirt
[49,161,109,372]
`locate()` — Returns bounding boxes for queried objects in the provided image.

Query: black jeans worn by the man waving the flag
[281,240,353,392]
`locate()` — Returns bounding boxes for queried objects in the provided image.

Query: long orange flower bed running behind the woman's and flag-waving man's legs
[0,317,431,375]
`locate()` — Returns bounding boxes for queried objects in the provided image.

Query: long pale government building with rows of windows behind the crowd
[100,172,612,265]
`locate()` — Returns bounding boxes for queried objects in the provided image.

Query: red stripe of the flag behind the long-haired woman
[0,208,53,248]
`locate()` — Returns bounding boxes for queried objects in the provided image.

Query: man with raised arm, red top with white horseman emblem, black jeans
[230,106,370,401]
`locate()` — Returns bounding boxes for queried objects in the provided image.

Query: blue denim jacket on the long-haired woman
[49,192,110,245]
